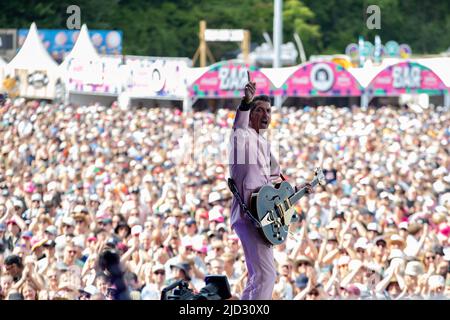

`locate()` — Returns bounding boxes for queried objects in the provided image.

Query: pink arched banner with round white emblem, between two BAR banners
[281,62,361,97]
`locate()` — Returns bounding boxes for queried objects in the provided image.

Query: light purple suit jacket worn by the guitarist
[229,107,280,228]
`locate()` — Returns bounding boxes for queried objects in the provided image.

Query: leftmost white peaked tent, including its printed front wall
[6,22,59,99]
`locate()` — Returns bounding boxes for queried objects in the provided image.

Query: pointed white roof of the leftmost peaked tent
[8,22,58,70]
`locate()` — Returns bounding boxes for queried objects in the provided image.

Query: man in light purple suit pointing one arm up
[230,77,312,300]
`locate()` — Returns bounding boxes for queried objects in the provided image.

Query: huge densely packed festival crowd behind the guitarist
[0,98,450,300]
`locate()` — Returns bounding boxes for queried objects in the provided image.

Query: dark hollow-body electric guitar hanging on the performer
[250,168,325,245]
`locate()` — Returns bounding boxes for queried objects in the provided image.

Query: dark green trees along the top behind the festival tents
[0,0,450,59]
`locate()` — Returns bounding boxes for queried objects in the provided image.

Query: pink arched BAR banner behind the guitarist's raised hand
[189,61,275,98]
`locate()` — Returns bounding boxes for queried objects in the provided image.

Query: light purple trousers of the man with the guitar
[233,219,277,300]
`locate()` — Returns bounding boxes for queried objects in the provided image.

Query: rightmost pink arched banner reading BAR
[367,62,447,96]
